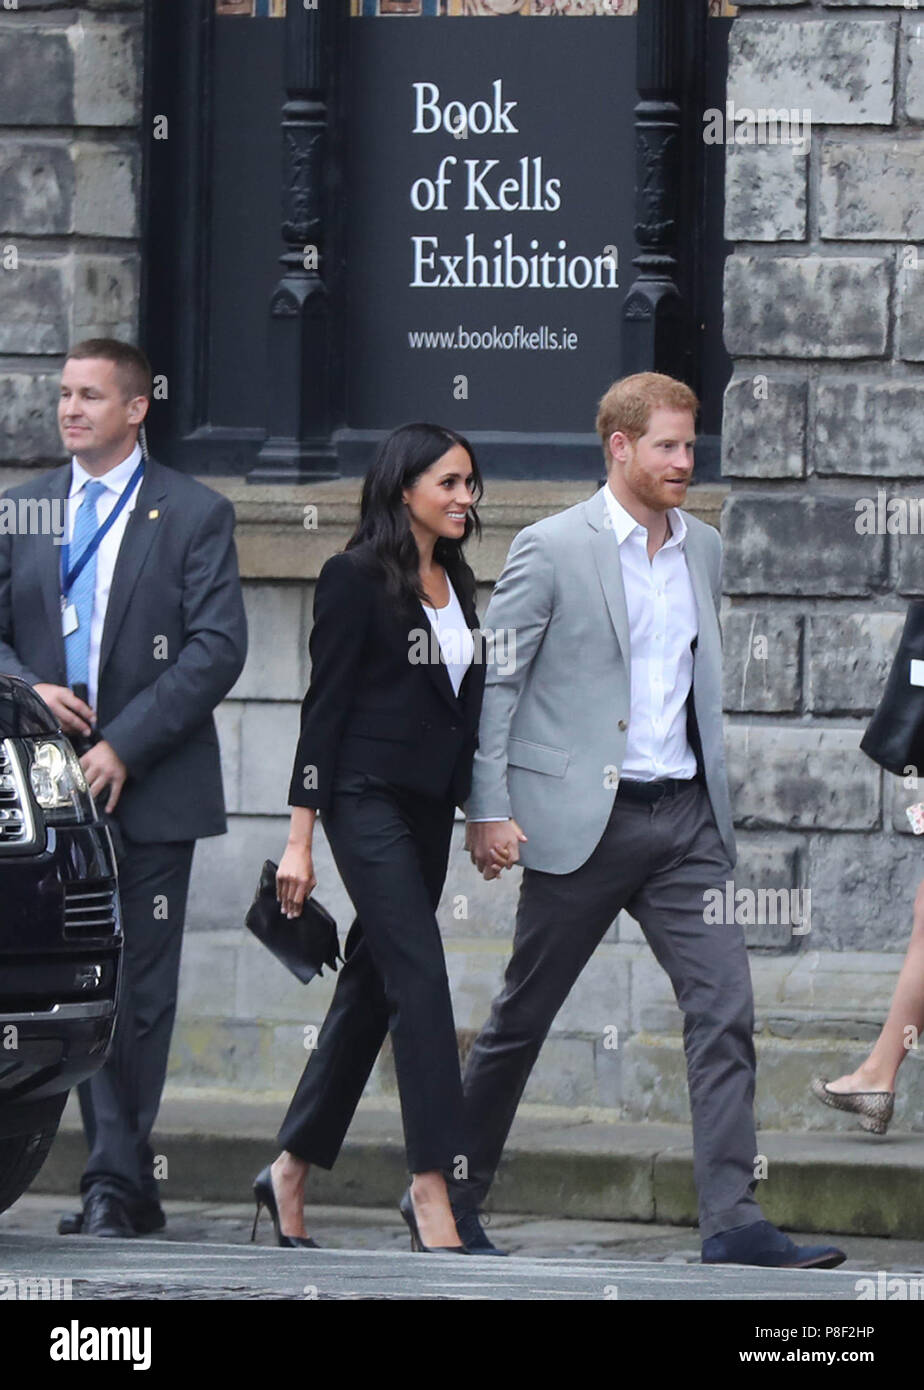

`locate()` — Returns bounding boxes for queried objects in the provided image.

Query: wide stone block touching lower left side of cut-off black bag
[727,724,881,822]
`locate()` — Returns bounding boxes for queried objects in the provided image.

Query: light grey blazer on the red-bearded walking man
[465,489,736,873]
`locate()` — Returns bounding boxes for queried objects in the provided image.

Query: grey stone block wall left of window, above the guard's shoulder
[0,0,145,467]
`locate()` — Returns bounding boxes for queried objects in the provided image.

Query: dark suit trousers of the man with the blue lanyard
[78,835,195,1208]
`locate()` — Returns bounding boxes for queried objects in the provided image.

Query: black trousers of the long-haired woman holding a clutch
[272,771,465,1173]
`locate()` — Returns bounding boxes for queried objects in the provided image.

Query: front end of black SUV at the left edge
[0,676,122,1211]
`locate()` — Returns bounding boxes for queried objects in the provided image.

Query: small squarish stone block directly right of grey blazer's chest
[723,607,803,713]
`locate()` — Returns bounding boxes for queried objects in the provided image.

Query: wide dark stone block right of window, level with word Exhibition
[725,254,889,359]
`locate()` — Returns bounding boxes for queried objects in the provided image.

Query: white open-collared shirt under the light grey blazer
[603,484,699,781]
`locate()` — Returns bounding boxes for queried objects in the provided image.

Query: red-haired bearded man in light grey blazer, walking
[453,373,845,1268]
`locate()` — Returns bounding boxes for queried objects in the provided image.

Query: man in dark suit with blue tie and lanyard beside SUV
[0,338,247,1236]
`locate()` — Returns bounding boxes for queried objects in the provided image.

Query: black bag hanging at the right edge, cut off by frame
[860,603,924,777]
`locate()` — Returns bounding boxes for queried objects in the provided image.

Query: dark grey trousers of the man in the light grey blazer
[452,781,763,1238]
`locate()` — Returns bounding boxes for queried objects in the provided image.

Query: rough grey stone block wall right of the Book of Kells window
[723,0,924,956]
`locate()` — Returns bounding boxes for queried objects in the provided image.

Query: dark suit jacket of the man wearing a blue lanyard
[0,459,247,842]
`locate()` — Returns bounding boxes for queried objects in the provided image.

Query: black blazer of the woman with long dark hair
[289,545,485,810]
